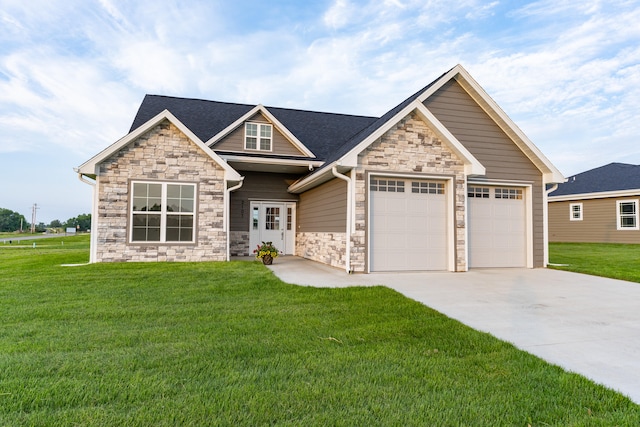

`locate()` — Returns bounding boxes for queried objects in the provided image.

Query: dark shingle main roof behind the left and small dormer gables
[130,95,377,160]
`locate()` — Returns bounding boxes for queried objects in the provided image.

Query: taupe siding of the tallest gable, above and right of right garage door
[424,80,544,267]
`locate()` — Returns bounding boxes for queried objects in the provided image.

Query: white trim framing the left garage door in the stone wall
[364,170,457,273]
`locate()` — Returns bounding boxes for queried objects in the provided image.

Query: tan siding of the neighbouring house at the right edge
[549,195,640,243]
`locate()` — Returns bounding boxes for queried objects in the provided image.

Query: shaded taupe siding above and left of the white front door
[229,172,299,231]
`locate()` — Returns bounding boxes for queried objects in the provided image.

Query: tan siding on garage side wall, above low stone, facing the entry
[297,178,347,233]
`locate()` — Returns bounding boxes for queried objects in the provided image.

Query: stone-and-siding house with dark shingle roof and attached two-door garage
[76,65,564,273]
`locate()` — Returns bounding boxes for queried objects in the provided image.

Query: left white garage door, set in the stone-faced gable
[369,177,448,271]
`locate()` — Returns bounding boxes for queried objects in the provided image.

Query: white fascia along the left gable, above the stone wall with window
[78,110,241,181]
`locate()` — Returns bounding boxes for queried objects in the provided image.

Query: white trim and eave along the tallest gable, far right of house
[417,64,566,183]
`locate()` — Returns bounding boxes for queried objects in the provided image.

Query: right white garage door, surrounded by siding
[467,185,527,268]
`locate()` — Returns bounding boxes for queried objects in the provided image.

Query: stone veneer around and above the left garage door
[351,113,467,272]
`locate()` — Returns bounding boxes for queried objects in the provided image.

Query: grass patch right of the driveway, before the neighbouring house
[549,243,640,282]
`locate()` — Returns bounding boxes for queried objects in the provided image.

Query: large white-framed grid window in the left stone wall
[131,182,196,243]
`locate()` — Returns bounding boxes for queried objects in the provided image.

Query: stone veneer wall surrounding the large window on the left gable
[95,120,227,262]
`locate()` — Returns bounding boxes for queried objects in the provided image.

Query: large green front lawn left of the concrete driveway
[0,236,640,426]
